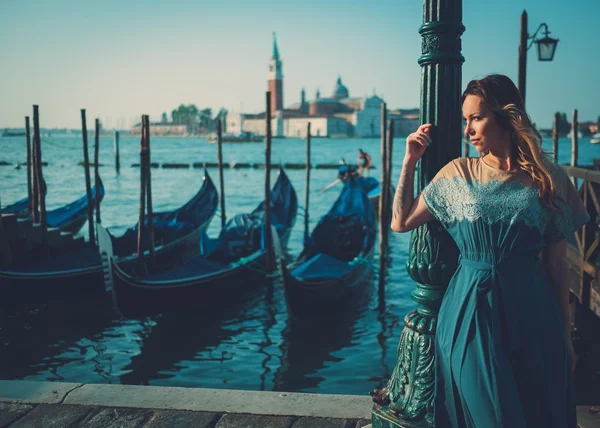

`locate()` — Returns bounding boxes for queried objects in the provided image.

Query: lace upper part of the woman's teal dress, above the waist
[422,158,589,244]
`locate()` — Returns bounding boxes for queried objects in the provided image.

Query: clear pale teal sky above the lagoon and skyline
[0,0,600,128]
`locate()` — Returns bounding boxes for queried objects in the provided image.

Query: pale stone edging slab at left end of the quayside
[0,380,83,404]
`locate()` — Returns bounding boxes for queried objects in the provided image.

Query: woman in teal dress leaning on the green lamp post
[392,75,589,428]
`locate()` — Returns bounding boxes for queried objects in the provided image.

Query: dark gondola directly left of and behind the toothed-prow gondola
[0,172,218,305]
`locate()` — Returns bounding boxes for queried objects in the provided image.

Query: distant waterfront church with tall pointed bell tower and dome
[226,34,383,138]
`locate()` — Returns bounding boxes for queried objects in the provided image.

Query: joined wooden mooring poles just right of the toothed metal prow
[137,115,155,264]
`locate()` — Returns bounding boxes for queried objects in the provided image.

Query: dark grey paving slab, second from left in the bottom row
[10,404,94,428]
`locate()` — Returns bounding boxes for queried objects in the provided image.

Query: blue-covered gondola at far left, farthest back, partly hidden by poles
[2,180,104,233]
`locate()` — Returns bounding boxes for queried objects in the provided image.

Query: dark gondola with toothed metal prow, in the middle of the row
[98,169,298,313]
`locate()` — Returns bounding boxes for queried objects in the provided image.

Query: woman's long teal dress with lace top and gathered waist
[422,158,589,428]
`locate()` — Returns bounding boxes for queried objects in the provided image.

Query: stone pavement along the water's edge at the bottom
[0,381,600,428]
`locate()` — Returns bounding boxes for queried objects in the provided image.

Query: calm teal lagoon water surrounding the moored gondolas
[0,137,600,395]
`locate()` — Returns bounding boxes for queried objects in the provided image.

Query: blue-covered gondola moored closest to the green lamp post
[281,177,377,312]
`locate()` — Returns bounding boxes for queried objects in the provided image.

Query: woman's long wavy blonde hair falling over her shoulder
[462,74,558,210]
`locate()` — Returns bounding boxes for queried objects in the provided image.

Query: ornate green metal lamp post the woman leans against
[372,0,465,428]
